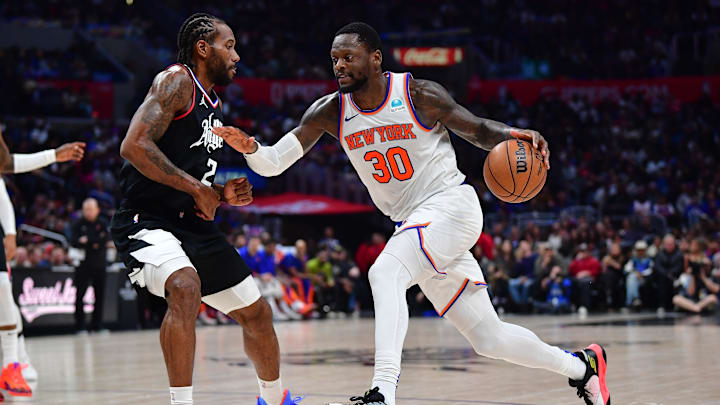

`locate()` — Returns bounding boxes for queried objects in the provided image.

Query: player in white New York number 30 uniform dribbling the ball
[215,23,610,405]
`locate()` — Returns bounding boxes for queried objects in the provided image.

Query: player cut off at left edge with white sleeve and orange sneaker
[0,124,85,396]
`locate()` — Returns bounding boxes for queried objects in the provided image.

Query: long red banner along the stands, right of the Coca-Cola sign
[468,76,720,106]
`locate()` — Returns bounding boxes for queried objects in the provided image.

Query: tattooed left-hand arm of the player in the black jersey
[120,66,220,219]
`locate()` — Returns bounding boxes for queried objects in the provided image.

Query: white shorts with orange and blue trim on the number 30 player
[383,185,487,316]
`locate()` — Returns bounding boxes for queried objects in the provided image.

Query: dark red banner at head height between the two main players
[233,78,337,105]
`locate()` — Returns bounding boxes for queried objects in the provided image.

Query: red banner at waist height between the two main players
[237,193,375,215]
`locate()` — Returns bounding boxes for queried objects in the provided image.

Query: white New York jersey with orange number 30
[338,73,465,222]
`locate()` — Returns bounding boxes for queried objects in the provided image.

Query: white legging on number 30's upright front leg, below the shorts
[368,254,412,405]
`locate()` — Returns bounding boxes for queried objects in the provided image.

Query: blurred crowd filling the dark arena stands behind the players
[0,0,720,325]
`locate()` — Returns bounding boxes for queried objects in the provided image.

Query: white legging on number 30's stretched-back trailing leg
[445,289,586,380]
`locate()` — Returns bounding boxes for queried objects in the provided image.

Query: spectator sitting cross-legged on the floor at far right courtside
[673,239,720,313]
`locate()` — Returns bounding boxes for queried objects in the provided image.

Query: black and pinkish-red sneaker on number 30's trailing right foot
[568,343,610,405]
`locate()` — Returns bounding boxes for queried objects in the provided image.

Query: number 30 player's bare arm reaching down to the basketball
[410,79,550,169]
